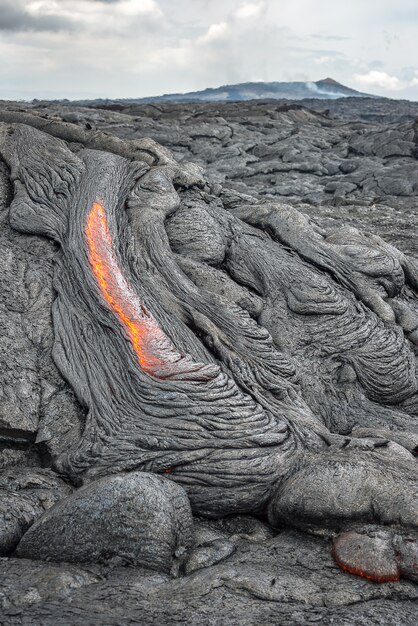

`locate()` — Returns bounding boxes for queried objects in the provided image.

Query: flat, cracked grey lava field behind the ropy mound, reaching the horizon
[22,98,418,245]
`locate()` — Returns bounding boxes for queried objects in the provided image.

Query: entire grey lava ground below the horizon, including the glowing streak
[0,99,418,624]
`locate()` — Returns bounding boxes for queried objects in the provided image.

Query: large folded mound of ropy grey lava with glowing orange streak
[0,116,418,581]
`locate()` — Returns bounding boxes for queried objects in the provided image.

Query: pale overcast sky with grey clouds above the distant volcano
[0,0,418,100]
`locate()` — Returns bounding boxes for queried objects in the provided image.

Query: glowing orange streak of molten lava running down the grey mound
[85,202,188,378]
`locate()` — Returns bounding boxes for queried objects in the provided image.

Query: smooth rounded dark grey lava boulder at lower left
[16,472,192,571]
